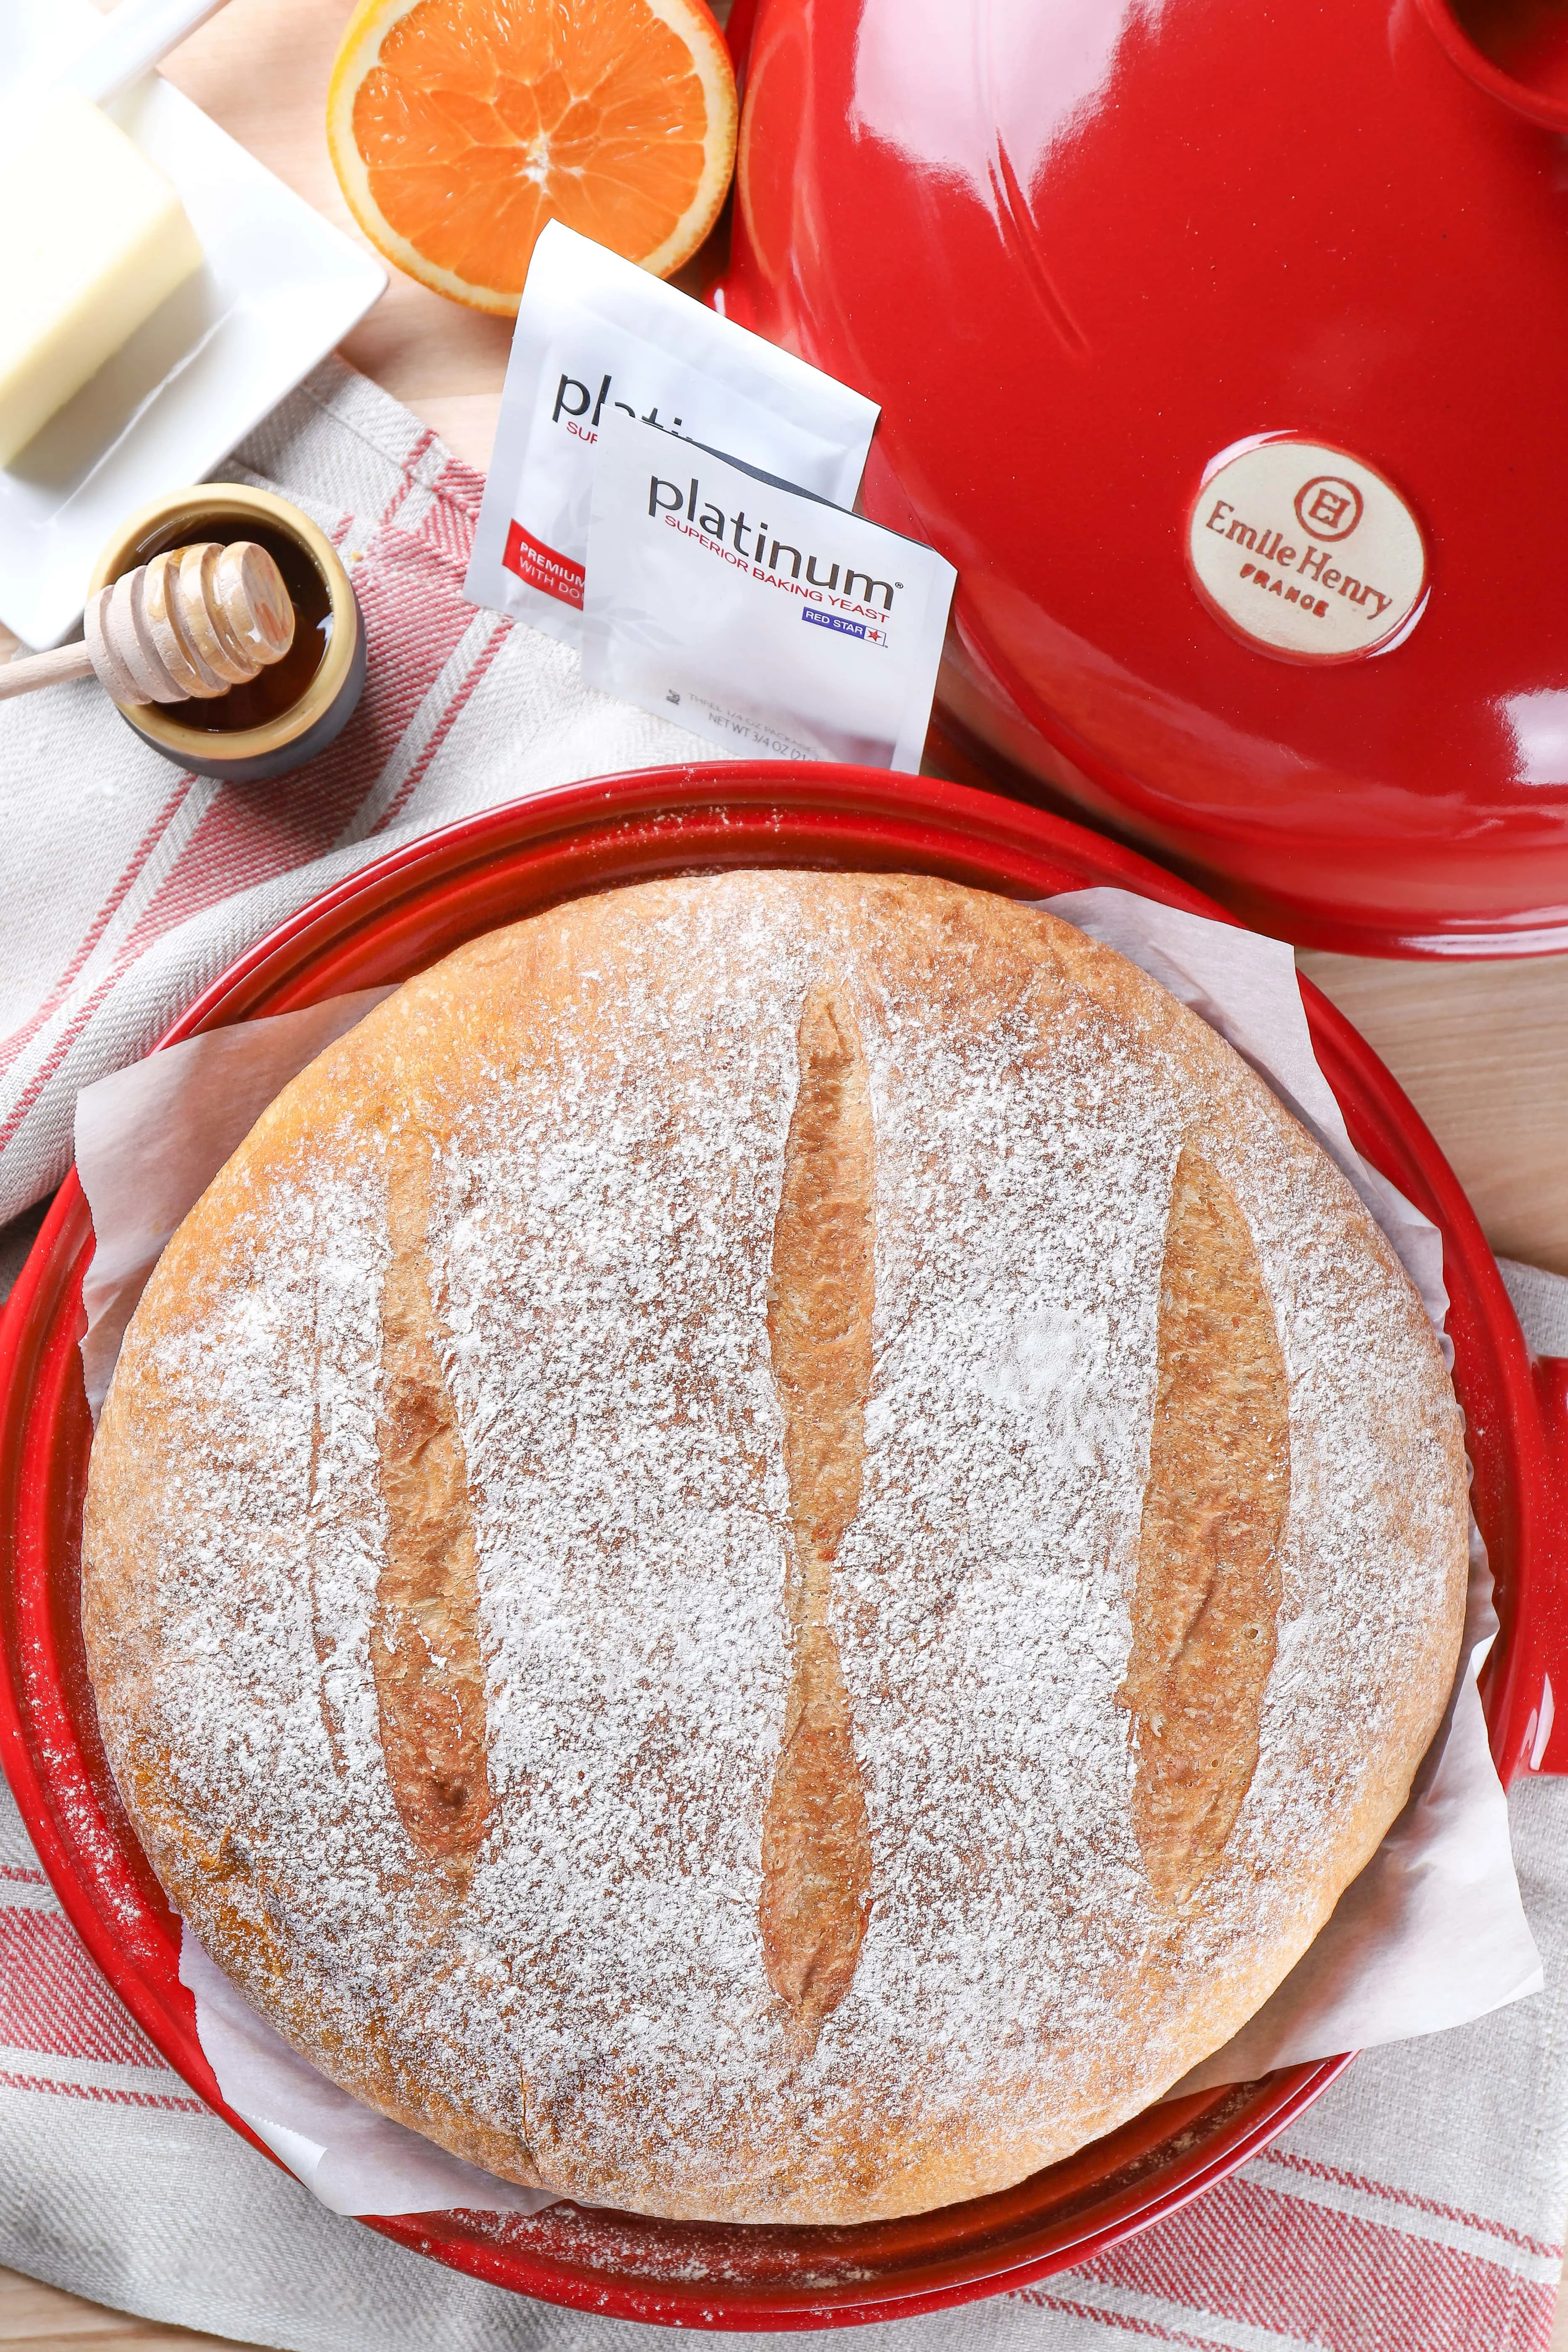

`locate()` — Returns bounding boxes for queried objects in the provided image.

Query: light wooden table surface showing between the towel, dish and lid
[0,0,1568,2352]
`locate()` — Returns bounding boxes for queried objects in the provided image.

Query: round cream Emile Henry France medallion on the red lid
[1187,433,1427,663]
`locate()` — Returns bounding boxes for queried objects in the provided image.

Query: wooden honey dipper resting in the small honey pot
[0,539,294,703]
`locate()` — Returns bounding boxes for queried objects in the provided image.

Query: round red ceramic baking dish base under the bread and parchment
[0,764,1563,2328]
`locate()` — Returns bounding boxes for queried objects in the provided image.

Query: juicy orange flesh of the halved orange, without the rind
[353,0,708,294]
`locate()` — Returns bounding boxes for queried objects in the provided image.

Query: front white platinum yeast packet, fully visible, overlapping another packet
[583,416,957,771]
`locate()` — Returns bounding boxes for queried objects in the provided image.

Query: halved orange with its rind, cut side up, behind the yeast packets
[327,0,736,315]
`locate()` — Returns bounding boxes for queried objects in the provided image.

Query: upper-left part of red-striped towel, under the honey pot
[0,360,724,1225]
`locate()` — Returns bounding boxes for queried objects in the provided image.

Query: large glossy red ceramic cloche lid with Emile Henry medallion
[719,0,1568,955]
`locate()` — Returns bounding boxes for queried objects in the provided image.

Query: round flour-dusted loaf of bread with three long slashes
[82,873,1467,2223]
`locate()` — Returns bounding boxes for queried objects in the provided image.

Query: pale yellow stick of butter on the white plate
[0,94,202,466]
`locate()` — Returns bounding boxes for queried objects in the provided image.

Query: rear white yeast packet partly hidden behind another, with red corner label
[463,221,879,645]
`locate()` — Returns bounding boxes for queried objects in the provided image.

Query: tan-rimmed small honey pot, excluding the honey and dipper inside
[87,482,360,767]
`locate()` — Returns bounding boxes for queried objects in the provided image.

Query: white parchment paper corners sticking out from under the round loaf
[75,889,1542,2213]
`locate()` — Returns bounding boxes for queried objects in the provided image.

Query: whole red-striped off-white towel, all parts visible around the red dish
[0,362,1568,2352]
